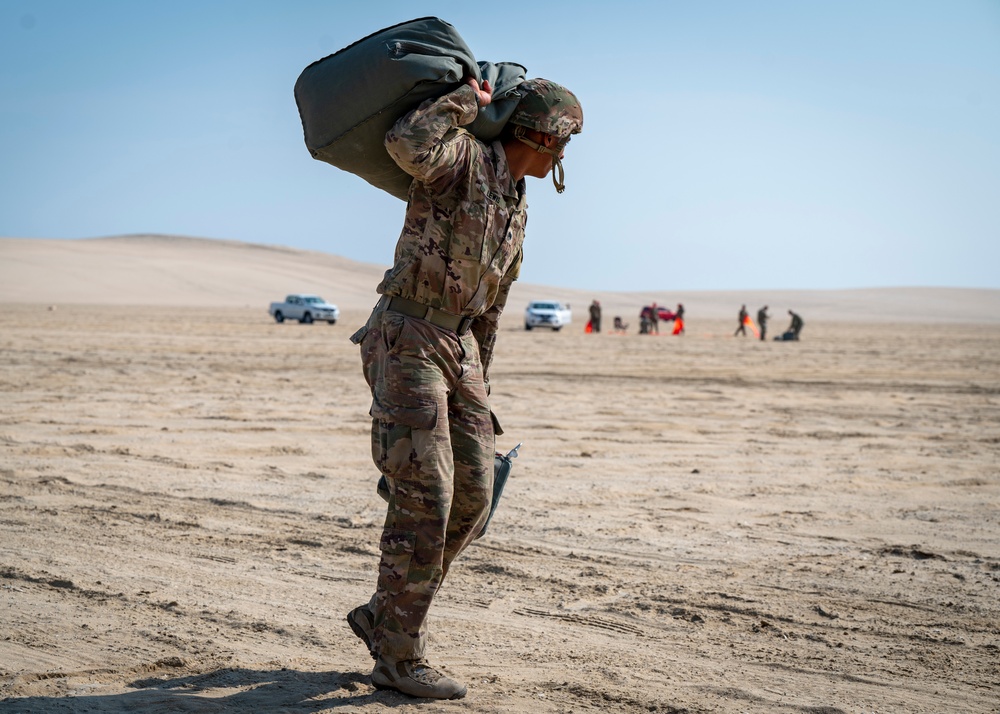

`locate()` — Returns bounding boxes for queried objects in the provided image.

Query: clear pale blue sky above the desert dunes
[0,0,1000,290]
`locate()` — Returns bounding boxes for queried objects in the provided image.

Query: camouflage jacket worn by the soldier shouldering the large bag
[378,85,527,379]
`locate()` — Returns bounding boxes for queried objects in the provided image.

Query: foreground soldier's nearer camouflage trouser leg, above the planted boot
[364,313,462,660]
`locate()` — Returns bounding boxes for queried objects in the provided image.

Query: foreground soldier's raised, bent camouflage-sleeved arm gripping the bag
[385,84,479,183]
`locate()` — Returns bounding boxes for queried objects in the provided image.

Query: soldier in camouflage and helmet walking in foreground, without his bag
[347,78,583,699]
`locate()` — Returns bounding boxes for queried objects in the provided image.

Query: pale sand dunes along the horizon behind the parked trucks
[0,236,1000,324]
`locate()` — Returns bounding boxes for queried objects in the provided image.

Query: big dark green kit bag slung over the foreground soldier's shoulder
[295,17,527,201]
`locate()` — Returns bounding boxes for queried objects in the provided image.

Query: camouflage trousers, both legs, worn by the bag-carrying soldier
[361,311,495,659]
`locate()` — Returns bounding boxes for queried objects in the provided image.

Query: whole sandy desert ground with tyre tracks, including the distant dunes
[0,237,1000,714]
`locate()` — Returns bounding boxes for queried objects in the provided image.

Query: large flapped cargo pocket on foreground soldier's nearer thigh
[369,392,438,478]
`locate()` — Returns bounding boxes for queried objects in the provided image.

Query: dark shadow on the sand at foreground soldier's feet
[0,668,425,714]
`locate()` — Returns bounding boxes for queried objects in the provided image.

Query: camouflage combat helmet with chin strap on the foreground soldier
[509,79,583,193]
